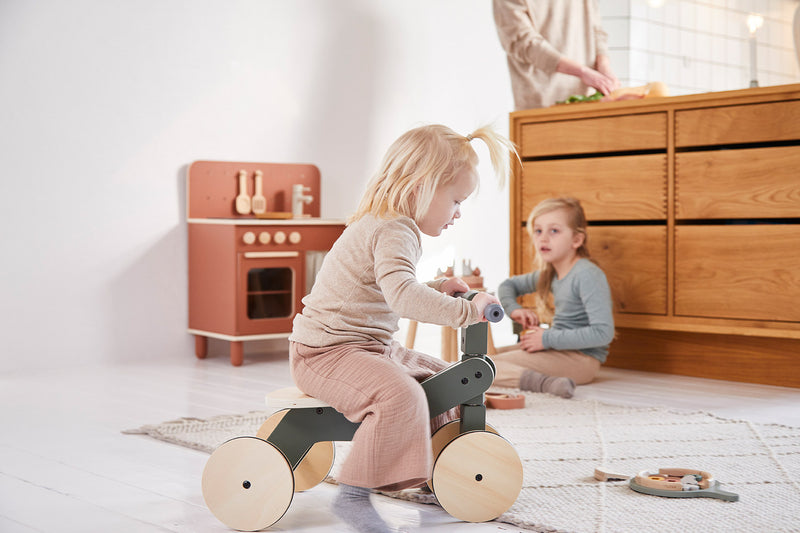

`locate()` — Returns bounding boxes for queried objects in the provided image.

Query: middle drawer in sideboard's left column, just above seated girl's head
[520,154,667,220]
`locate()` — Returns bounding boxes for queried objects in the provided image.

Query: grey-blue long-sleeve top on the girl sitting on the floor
[497,258,614,363]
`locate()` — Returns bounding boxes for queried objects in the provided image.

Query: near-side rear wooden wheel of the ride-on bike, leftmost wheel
[202,437,294,531]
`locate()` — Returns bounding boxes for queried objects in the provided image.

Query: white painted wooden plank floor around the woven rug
[0,330,800,533]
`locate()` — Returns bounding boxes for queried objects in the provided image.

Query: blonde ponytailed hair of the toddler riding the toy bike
[348,124,516,224]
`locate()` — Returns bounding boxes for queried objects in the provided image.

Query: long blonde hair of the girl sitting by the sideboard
[525,196,591,324]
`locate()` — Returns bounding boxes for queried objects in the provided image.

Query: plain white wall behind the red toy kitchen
[0,0,796,372]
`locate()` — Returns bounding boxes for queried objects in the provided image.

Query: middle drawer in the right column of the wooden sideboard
[675,146,800,219]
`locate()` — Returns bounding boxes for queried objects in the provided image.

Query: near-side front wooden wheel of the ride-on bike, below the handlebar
[432,431,522,522]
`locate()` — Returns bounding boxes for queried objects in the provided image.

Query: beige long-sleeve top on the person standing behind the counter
[494,0,608,110]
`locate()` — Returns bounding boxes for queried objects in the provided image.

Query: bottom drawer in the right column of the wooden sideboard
[675,224,800,322]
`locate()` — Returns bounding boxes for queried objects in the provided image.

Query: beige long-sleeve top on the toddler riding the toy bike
[289,215,481,347]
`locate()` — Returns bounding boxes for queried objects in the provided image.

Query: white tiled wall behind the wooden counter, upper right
[599,0,800,95]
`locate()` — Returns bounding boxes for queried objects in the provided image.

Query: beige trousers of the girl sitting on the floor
[490,344,600,388]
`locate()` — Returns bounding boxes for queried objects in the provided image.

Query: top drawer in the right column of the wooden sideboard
[675,100,800,148]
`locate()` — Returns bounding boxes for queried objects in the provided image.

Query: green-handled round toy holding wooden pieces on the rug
[630,468,739,502]
